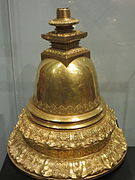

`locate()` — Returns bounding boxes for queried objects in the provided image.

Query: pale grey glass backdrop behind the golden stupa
[0,0,135,170]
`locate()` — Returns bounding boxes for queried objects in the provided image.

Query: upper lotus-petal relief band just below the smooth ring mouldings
[16,108,116,149]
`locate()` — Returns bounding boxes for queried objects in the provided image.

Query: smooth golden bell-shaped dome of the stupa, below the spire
[34,57,100,115]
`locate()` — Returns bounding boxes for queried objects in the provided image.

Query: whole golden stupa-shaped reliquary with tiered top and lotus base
[8,8,127,179]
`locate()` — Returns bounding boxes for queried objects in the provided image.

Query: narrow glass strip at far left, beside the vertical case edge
[0,0,17,168]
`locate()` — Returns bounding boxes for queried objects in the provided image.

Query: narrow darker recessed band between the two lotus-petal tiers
[25,136,110,160]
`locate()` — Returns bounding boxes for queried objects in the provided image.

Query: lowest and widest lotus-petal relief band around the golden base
[8,127,127,179]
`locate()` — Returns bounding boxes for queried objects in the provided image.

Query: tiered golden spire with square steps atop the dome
[41,8,90,66]
